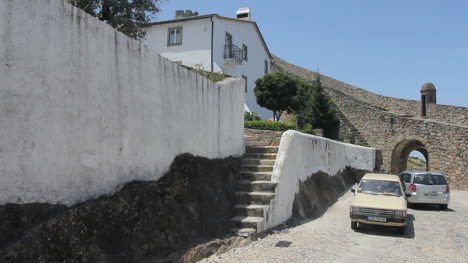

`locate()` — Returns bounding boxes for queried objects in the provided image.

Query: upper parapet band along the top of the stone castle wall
[273,56,468,126]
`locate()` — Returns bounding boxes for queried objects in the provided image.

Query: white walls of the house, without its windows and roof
[144,16,273,119]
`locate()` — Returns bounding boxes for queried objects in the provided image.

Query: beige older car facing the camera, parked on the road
[349,173,407,234]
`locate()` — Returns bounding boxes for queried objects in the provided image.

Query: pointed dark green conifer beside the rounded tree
[295,74,339,138]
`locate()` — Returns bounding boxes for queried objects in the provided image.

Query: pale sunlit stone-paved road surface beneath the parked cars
[200,190,468,263]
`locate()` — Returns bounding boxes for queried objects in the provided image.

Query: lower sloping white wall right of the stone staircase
[259,130,376,231]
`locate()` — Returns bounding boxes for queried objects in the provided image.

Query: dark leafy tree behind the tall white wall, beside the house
[68,0,164,39]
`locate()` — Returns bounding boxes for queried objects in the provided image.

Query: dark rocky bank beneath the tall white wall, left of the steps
[0,154,241,263]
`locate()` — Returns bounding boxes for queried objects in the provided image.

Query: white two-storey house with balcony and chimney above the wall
[144,8,272,119]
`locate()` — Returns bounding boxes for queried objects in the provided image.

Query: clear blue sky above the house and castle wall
[156,0,468,107]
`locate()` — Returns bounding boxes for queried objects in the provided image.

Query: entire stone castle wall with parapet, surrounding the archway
[273,57,468,189]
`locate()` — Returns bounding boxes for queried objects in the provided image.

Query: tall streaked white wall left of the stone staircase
[0,0,244,204]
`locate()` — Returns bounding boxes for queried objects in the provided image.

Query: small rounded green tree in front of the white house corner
[254,72,297,121]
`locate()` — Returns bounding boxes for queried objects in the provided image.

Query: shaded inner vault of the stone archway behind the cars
[391,139,429,174]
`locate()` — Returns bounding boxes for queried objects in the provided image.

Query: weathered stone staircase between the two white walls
[231,136,278,236]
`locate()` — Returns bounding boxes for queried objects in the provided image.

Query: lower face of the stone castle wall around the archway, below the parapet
[329,90,468,189]
